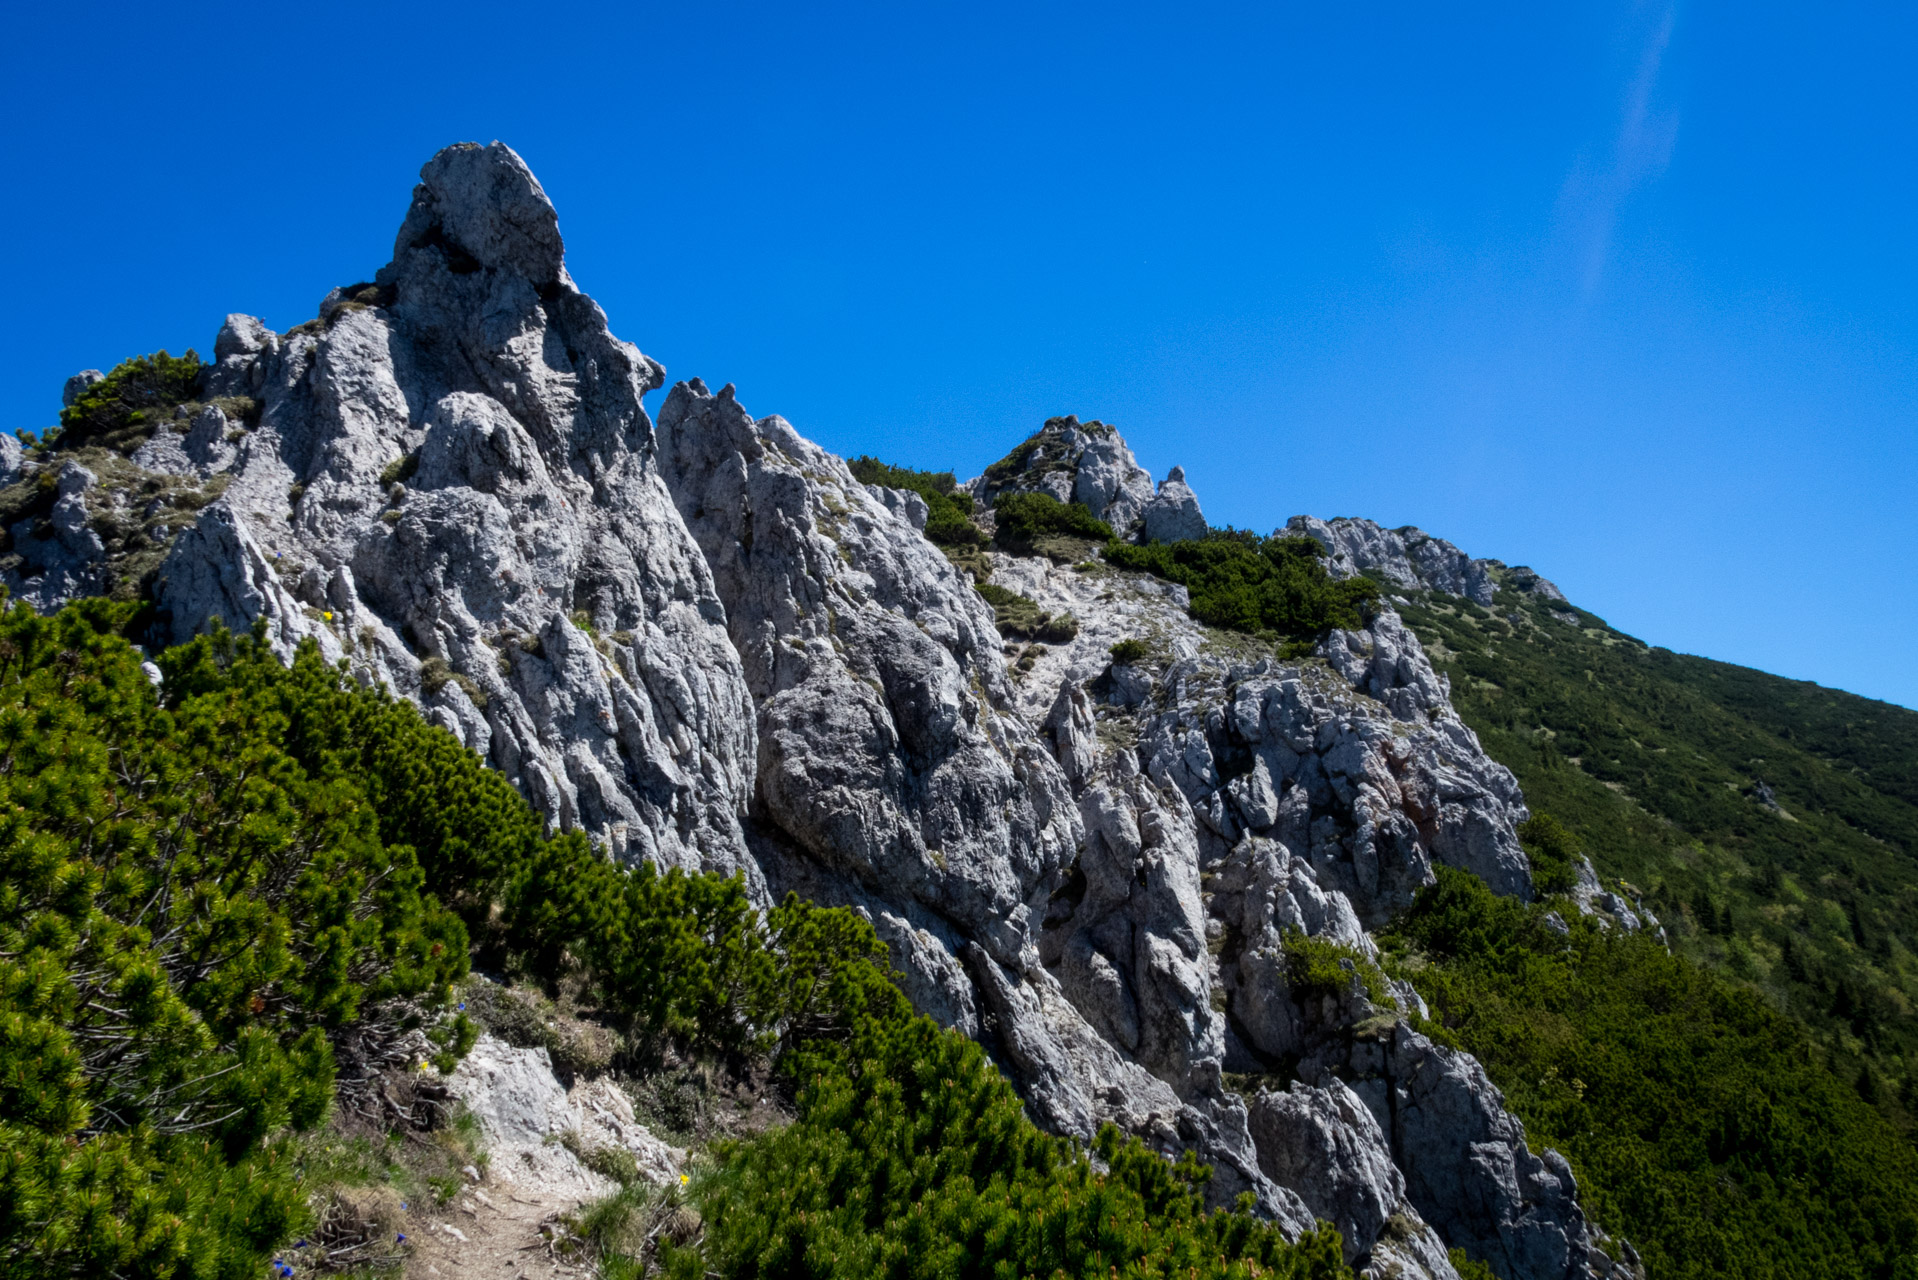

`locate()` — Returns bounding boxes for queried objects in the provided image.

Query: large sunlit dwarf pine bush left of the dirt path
[0,601,468,1276]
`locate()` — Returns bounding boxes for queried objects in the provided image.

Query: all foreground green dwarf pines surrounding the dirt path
[0,601,1348,1280]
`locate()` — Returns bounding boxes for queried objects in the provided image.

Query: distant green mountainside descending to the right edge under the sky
[1400,591,1918,1126]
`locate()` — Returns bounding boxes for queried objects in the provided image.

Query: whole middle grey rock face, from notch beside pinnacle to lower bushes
[660,382,1310,1230]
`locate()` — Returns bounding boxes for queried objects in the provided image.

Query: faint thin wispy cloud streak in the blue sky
[1559,4,1678,297]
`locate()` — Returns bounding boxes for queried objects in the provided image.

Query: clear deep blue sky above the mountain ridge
[0,2,1918,706]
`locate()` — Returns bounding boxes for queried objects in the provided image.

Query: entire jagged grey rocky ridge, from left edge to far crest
[0,142,1636,1280]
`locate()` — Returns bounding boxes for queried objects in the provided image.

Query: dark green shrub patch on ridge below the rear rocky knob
[1105,530,1379,641]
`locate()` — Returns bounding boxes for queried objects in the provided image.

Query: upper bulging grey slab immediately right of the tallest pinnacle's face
[660,384,1078,965]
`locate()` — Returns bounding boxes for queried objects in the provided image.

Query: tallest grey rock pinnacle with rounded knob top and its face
[38,144,758,879]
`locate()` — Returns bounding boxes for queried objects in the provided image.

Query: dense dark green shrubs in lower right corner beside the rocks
[1387,867,1918,1280]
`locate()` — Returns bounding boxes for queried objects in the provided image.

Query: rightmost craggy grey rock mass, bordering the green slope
[994,558,1609,1276]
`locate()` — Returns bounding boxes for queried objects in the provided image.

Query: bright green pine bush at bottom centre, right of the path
[696,1017,1350,1280]
